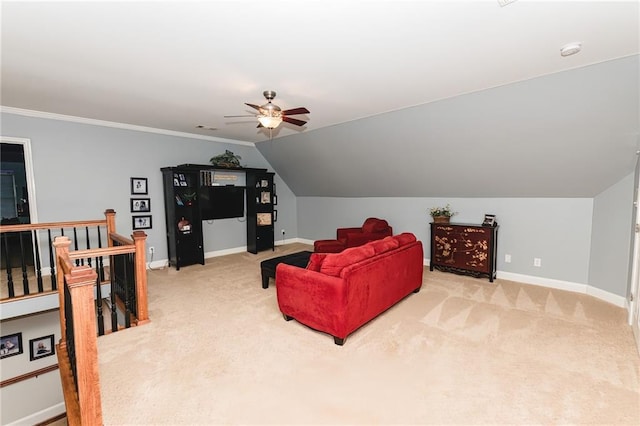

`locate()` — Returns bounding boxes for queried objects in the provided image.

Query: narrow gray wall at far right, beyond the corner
[589,173,634,296]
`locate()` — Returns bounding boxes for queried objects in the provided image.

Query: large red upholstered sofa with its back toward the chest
[276,233,423,345]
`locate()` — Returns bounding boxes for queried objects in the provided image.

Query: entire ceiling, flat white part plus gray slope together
[0,0,640,197]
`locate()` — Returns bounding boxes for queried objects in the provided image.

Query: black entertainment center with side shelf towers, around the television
[160,164,276,270]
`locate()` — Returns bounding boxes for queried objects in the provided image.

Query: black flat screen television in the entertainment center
[200,186,244,220]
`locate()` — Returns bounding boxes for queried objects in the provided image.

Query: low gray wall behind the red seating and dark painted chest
[298,197,596,286]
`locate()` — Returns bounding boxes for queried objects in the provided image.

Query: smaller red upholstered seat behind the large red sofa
[313,217,393,253]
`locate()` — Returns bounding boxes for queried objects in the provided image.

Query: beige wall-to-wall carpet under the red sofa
[99,244,640,425]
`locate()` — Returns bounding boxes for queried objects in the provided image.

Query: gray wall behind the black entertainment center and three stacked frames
[1,113,297,259]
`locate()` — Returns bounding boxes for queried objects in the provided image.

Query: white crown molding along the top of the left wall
[0,105,255,146]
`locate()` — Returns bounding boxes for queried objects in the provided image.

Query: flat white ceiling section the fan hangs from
[1,0,639,142]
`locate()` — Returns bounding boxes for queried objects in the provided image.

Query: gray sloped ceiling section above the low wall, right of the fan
[256,55,640,197]
